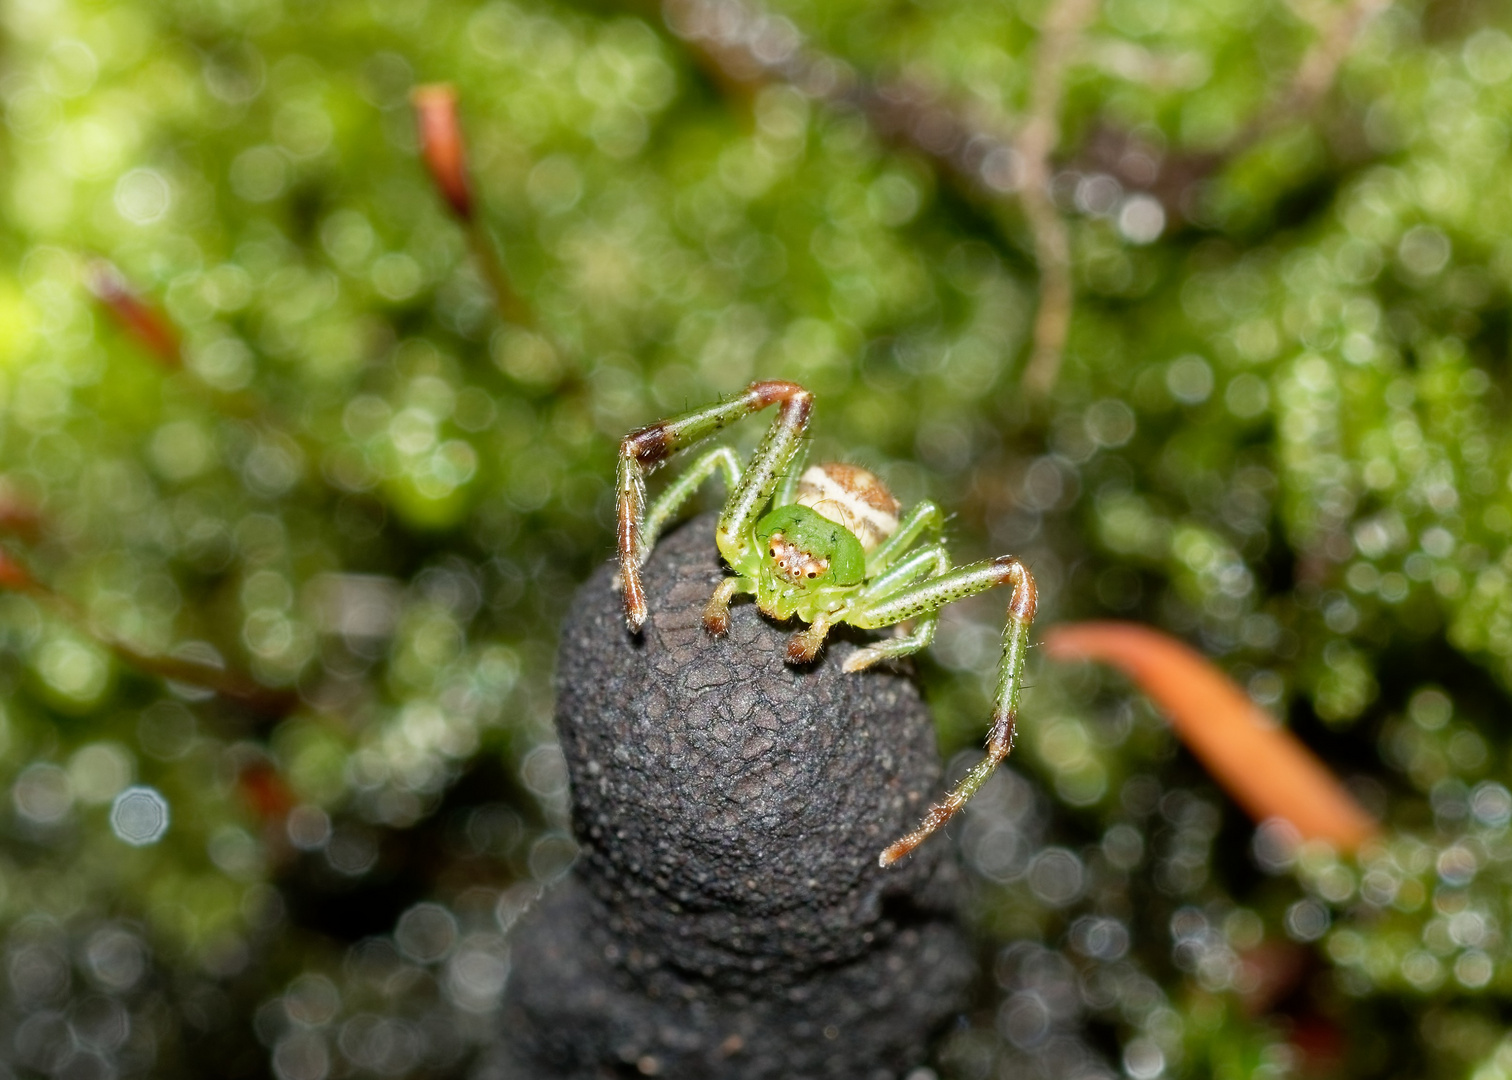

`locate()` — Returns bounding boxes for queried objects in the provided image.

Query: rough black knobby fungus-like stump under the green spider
[481,517,975,1080]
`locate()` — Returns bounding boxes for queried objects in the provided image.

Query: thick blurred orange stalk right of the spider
[1045,622,1380,852]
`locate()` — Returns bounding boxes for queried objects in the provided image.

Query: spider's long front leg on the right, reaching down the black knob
[847,555,1039,867]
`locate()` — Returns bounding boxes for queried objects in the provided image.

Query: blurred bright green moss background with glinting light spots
[0,0,1512,1080]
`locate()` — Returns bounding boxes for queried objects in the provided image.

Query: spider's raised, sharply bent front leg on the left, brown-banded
[615,381,813,631]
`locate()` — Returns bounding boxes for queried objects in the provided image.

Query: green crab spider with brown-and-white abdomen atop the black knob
[617,381,1037,867]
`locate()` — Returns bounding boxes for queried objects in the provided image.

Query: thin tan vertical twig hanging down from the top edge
[1018,0,1098,396]
